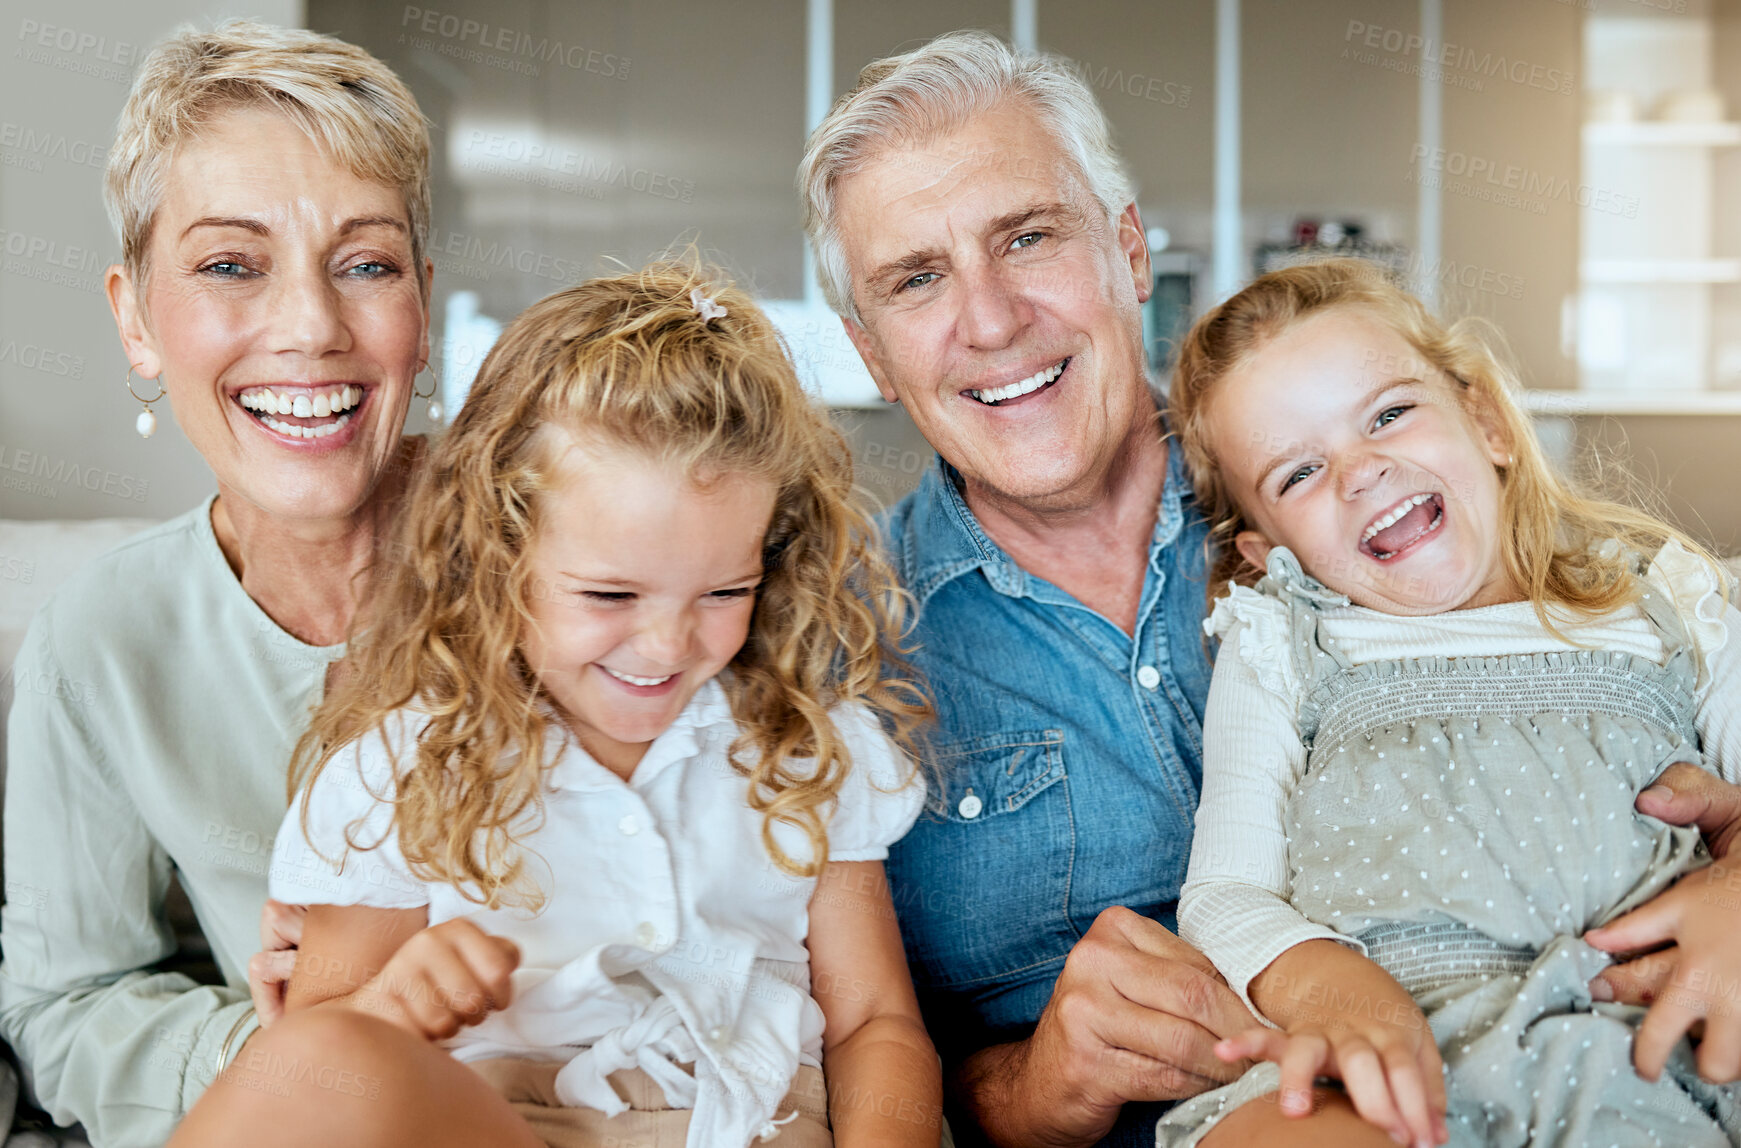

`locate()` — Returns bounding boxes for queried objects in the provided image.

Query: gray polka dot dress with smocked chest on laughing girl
[1158,550,1741,1148]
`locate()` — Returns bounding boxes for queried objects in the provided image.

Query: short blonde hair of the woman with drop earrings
[103,19,430,287]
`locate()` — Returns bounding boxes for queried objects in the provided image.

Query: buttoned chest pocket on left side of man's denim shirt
[888,730,1081,988]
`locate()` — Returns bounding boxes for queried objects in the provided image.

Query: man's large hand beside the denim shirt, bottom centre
[959,906,1254,1148]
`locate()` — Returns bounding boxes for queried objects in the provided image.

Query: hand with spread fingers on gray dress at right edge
[1584,861,1741,1084]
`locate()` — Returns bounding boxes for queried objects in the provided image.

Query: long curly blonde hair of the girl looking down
[289,263,928,908]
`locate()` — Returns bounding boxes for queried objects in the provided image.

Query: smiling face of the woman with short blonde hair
[111,106,428,517]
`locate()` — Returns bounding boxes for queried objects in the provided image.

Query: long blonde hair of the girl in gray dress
[1168,260,1727,634]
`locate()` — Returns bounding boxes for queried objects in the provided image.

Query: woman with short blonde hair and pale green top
[0,23,430,1145]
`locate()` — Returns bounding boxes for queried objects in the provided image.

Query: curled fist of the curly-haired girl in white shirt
[348,916,521,1040]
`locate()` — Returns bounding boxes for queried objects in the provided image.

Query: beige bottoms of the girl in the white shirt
[470,1059,834,1148]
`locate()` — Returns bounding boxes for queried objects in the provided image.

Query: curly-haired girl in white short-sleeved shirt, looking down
[166,265,940,1148]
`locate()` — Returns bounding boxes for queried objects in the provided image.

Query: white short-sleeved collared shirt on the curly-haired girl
[272,681,924,1145]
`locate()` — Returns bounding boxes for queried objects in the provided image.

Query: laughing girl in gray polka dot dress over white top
[1160,260,1741,1148]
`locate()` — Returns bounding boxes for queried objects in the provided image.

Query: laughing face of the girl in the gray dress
[1208,307,1518,615]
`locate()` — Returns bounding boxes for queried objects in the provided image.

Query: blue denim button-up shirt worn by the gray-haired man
[883,444,1210,1145]
